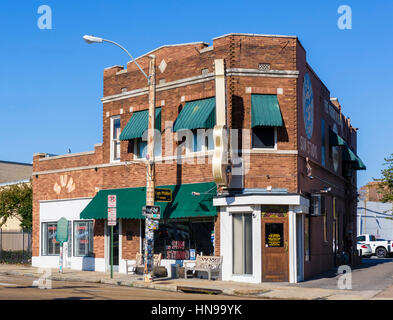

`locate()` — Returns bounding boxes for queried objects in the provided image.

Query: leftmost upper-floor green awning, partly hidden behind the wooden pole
[119,108,161,140]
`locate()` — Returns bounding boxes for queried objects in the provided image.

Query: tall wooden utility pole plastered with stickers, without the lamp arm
[143,55,156,282]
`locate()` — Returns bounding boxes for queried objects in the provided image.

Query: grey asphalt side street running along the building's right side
[296,257,393,292]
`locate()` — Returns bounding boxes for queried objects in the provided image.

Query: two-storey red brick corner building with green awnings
[33,34,365,282]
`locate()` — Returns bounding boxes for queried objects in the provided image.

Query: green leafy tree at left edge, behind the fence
[0,183,33,230]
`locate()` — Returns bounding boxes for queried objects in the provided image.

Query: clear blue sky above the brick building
[0,0,393,186]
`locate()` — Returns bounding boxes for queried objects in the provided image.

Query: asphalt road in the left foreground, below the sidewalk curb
[0,275,259,300]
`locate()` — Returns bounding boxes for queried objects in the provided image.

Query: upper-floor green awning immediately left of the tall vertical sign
[173,98,216,132]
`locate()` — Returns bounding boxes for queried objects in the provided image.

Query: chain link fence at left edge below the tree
[0,229,31,264]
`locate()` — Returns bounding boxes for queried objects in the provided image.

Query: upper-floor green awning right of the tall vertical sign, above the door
[251,94,283,128]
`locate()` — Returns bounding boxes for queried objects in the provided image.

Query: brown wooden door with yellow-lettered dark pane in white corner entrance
[261,217,289,282]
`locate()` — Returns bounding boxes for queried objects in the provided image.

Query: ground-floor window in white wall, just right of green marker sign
[74,221,94,257]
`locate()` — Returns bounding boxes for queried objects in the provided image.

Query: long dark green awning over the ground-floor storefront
[80,182,217,219]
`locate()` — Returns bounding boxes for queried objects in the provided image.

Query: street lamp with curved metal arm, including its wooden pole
[83,35,156,282]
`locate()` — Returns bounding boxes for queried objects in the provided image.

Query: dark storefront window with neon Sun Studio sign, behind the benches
[142,219,214,260]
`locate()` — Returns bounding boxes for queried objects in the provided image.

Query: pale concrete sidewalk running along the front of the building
[0,264,381,300]
